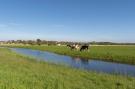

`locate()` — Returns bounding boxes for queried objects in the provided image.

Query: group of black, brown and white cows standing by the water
[67,44,89,51]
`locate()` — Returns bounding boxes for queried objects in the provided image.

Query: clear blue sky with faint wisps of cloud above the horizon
[0,0,135,42]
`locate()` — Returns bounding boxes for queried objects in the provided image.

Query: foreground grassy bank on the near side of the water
[0,48,135,89]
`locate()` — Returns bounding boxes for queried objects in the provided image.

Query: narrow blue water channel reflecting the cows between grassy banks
[11,48,135,77]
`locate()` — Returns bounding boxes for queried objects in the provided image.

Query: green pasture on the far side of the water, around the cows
[2,45,135,64]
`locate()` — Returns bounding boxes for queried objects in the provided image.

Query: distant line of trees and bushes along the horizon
[0,39,135,45]
